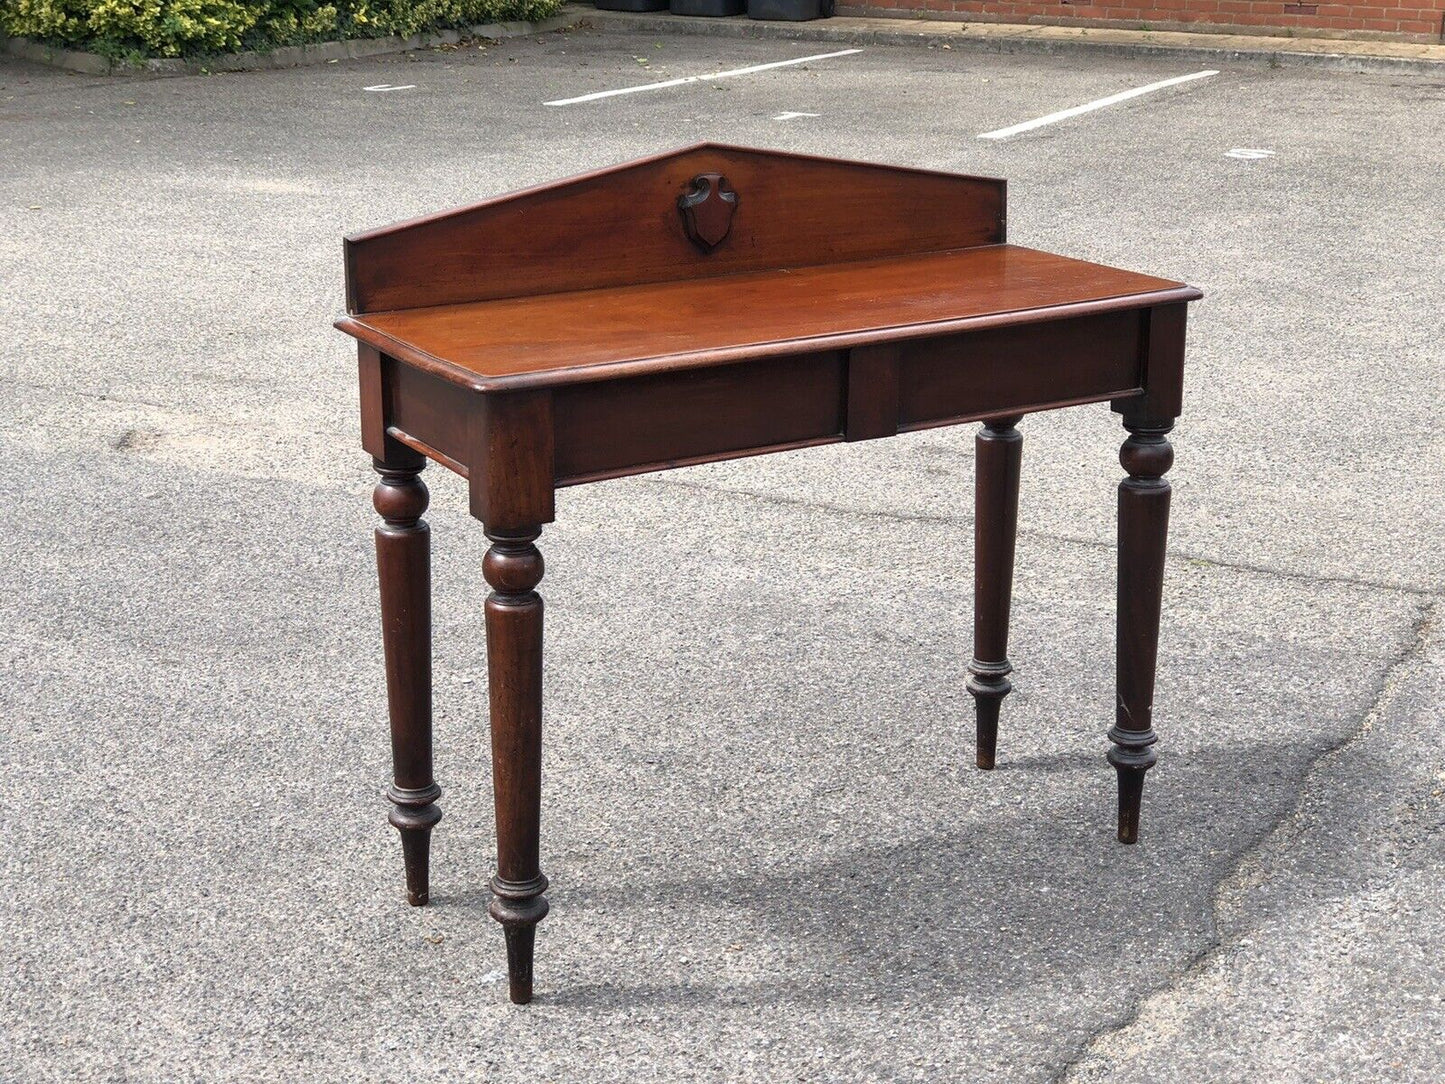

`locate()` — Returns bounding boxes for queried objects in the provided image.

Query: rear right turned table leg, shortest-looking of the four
[968,415,1023,769]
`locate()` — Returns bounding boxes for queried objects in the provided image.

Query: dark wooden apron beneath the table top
[361,306,1150,500]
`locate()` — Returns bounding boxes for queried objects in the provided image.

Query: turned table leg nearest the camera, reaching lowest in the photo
[483,528,548,1005]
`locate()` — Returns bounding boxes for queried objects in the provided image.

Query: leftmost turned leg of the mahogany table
[371,451,442,906]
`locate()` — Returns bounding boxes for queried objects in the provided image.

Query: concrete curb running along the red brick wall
[566,6,1445,75]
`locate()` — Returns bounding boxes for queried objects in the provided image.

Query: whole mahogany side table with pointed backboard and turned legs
[337,145,1201,1003]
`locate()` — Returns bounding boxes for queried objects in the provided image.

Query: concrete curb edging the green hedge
[4,7,584,75]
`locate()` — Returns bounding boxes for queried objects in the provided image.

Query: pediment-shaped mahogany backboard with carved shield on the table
[347,143,1006,314]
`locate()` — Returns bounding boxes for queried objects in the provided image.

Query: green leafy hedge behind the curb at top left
[0,0,561,56]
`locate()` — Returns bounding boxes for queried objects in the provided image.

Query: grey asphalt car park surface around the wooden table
[0,30,1445,1081]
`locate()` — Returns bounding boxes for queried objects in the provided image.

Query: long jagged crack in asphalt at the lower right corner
[1052,601,1442,1084]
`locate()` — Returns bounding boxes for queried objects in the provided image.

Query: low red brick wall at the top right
[838,0,1445,42]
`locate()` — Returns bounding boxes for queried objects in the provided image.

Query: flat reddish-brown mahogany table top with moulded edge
[337,244,1201,392]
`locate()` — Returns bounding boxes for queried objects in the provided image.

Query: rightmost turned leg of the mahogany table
[1108,415,1173,843]
